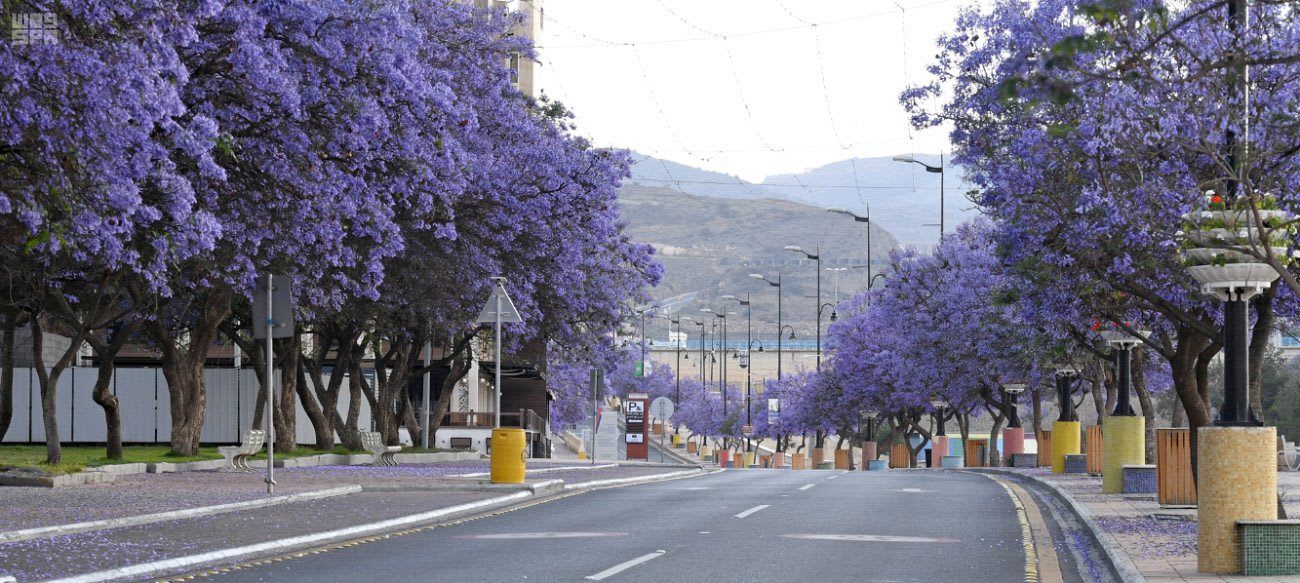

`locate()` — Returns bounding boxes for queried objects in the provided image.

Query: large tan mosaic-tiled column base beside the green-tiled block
[1196,427,1278,573]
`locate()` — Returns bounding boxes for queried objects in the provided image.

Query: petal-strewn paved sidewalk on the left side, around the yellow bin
[0,461,693,583]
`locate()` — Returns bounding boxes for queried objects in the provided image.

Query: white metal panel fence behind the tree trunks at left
[3,367,371,444]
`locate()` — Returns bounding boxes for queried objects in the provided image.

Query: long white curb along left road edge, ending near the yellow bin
[46,492,536,583]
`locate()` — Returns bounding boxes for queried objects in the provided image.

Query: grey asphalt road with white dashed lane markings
[192,470,1107,583]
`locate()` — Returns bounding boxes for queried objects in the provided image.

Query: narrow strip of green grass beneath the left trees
[0,445,356,475]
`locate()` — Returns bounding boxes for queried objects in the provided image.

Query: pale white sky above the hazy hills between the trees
[538,0,970,181]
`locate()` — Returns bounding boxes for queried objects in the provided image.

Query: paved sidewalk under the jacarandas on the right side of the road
[1000,467,1300,583]
